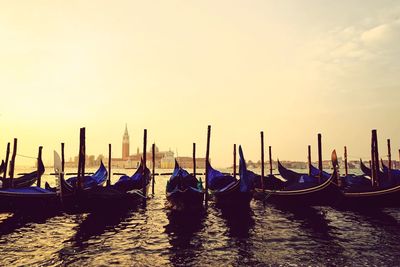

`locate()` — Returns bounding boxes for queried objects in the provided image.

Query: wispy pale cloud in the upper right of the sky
[306,5,400,96]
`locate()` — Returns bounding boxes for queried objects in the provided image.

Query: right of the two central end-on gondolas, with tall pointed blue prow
[206,146,254,208]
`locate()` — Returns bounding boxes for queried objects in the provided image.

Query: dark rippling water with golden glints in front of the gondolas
[0,169,400,266]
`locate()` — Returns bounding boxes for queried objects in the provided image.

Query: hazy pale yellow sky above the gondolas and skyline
[0,0,400,167]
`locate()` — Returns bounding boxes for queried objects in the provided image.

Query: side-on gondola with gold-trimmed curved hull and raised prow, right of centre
[255,151,342,207]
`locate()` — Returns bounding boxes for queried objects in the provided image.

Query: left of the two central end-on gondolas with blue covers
[166,160,204,210]
